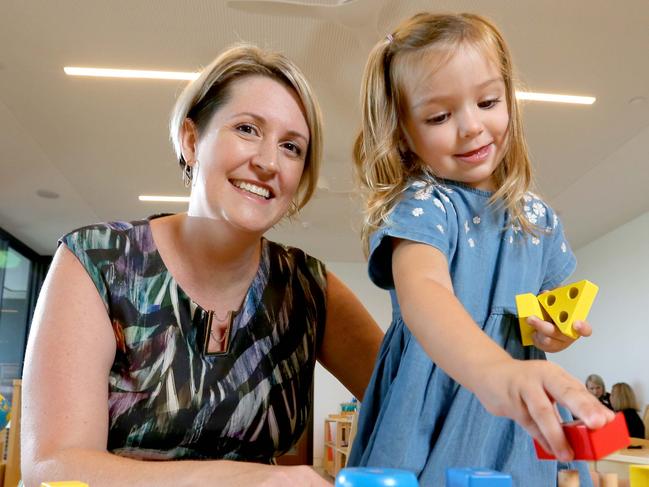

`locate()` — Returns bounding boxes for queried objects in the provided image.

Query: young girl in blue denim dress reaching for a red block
[350,14,613,487]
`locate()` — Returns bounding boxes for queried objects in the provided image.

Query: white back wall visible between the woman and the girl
[313,262,392,465]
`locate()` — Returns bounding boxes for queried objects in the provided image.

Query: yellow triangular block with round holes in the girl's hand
[538,280,599,338]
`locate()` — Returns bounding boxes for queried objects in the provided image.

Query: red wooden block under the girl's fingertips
[534,413,631,460]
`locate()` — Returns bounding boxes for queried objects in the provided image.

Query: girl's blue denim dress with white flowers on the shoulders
[348,179,592,487]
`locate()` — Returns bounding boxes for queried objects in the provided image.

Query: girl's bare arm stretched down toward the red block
[392,239,613,460]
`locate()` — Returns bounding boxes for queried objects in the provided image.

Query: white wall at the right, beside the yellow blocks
[551,212,649,408]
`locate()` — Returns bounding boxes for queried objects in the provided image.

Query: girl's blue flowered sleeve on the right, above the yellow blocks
[541,207,577,290]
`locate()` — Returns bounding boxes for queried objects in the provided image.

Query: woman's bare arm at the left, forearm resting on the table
[21,245,331,487]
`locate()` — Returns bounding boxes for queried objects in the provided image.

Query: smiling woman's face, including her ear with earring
[183,75,310,233]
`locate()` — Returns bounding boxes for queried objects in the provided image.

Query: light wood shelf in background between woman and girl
[322,412,358,477]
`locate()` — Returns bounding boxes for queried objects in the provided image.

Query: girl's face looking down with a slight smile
[404,46,509,191]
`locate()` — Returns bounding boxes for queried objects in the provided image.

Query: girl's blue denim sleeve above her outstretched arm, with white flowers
[369,181,458,289]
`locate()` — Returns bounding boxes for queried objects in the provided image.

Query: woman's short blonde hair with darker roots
[169,43,322,216]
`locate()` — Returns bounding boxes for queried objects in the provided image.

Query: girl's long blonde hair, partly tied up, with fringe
[354,13,534,253]
